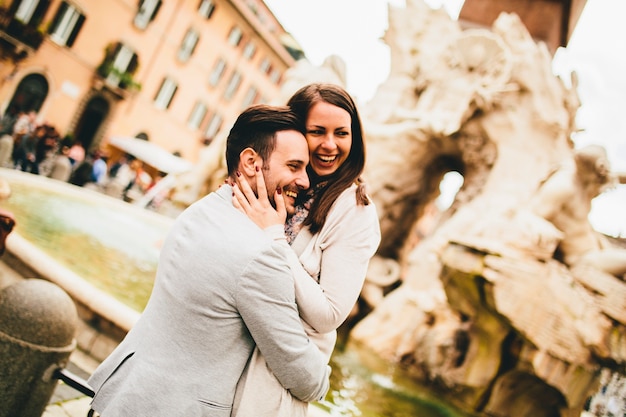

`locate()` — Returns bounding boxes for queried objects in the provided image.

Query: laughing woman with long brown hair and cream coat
[232,84,380,417]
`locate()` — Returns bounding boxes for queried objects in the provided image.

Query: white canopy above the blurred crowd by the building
[109,136,193,174]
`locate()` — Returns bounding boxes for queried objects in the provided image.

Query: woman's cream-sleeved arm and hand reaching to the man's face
[233,168,380,333]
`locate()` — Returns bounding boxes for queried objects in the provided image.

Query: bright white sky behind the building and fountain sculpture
[265,0,626,237]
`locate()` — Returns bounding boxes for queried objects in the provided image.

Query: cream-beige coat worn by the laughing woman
[233,186,380,417]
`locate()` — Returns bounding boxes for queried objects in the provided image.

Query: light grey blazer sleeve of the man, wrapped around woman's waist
[236,244,330,402]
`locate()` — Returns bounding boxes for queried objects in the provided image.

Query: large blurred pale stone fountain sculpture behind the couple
[171,0,626,417]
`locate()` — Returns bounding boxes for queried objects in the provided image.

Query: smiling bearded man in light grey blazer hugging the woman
[89,105,330,417]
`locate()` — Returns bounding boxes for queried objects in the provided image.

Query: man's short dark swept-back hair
[226,104,304,175]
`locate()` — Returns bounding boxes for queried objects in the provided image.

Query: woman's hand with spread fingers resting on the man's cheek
[233,166,287,229]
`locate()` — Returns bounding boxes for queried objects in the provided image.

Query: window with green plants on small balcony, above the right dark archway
[98,42,139,88]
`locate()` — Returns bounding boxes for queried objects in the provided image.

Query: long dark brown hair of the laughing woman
[287,83,370,233]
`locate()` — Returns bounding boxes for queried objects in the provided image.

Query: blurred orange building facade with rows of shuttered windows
[0,0,303,161]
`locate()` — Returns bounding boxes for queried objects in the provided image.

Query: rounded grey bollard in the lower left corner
[0,279,78,417]
